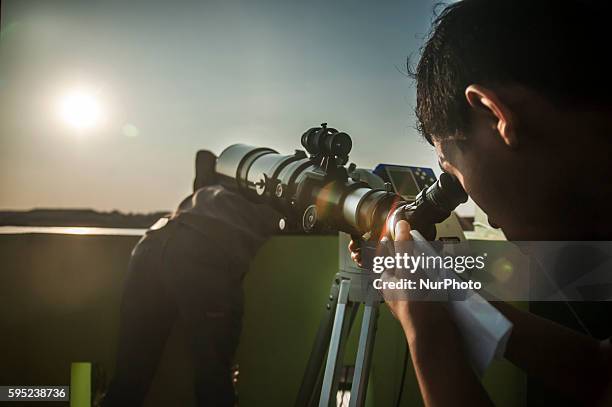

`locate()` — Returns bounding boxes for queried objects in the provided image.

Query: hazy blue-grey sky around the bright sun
[0,0,474,212]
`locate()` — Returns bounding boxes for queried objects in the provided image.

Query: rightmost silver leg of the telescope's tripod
[349,303,378,407]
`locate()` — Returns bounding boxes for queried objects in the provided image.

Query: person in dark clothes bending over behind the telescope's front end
[102,151,278,407]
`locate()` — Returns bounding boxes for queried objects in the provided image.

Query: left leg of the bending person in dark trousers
[102,236,177,407]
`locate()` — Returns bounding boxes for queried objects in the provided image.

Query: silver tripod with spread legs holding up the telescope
[295,239,381,407]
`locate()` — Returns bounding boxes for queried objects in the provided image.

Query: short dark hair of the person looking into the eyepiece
[408,0,612,143]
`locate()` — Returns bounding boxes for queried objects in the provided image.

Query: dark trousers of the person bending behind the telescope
[102,221,246,407]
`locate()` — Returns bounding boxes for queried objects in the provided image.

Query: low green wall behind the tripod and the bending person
[0,234,525,406]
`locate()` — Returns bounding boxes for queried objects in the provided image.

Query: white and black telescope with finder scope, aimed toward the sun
[216,123,467,240]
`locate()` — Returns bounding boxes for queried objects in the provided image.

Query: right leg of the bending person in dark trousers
[164,227,242,407]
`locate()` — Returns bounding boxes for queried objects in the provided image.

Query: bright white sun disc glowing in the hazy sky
[59,89,102,130]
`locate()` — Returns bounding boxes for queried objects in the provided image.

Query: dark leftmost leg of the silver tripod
[295,280,338,407]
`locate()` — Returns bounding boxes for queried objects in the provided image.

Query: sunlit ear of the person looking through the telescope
[465,85,518,148]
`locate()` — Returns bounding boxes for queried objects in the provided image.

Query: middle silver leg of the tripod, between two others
[319,280,353,407]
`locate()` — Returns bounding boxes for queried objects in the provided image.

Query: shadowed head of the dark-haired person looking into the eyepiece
[414,0,612,240]
